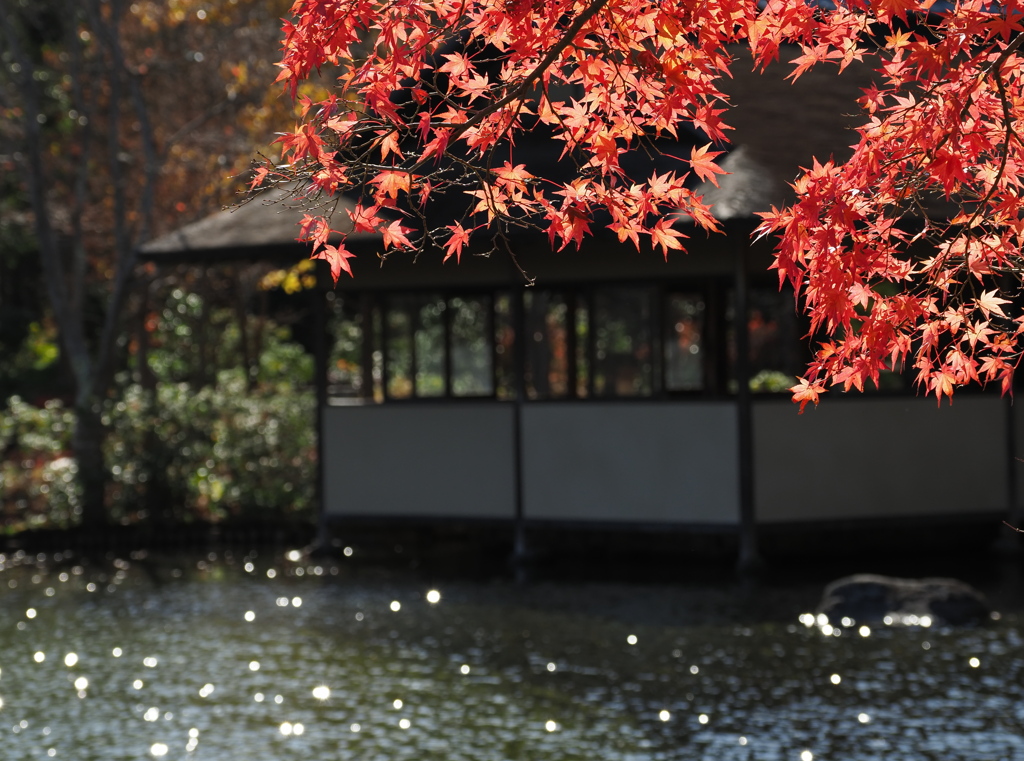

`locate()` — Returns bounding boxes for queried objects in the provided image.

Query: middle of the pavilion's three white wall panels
[523,401,739,524]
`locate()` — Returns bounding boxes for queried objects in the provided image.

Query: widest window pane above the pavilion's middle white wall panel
[591,288,653,396]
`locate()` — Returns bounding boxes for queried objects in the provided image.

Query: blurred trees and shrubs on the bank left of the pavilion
[0,0,315,535]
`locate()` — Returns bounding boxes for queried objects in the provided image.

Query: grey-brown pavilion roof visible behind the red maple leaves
[140,46,913,258]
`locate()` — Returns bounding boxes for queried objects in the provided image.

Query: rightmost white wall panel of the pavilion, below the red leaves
[754,394,1008,522]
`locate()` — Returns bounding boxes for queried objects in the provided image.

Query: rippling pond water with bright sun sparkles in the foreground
[0,553,1024,761]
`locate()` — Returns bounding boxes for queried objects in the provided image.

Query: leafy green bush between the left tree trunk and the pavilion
[106,369,316,521]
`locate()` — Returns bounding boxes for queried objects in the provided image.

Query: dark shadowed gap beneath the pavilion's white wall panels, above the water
[317,513,1010,584]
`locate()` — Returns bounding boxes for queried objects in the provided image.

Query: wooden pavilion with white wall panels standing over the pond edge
[140,49,1024,564]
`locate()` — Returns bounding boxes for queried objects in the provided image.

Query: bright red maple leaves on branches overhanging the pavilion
[266,0,1024,406]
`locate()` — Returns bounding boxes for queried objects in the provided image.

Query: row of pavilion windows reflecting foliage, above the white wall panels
[328,286,806,401]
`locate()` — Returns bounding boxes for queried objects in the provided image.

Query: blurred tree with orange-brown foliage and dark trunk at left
[0,0,291,523]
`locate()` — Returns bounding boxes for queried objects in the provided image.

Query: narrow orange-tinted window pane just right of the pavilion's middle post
[523,290,568,399]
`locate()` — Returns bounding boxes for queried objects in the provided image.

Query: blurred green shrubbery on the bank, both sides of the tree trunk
[0,289,316,531]
